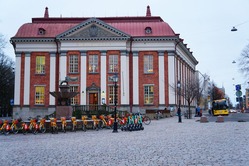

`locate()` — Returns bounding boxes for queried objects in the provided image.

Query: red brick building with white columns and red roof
[11,6,198,118]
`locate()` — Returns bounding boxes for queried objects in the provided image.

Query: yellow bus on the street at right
[212,99,229,116]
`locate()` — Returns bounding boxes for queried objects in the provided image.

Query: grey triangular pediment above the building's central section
[57,18,130,40]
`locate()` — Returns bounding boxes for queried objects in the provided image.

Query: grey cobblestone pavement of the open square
[0,117,249,166]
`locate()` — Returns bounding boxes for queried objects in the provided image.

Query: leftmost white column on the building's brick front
[14,54,22,105]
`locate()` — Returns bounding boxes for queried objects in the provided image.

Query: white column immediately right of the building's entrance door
[100,51,106,104]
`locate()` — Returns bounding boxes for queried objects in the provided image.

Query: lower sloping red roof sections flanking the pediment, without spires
[14,21,176,37]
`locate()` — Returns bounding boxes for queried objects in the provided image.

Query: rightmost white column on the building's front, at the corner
[168,53,176,104]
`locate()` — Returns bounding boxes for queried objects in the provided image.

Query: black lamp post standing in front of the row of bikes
[112,74,118,133]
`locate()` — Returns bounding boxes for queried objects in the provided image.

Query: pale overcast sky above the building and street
[0,0,249,103]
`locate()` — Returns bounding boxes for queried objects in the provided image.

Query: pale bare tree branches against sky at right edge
[238,44,249,79]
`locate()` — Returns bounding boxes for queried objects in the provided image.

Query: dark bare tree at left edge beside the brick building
[0,35,14,116]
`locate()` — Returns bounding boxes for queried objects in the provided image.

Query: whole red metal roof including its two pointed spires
[14,6,176,38]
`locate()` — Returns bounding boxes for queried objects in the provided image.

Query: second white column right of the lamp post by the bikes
[133,52,139,105]
